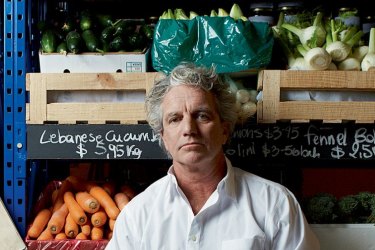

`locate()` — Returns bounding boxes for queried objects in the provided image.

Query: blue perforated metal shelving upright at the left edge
[2,0,28,235]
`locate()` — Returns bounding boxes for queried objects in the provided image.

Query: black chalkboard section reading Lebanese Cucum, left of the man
[27,124,166,159]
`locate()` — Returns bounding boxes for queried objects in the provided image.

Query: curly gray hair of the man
[145,63,237,150]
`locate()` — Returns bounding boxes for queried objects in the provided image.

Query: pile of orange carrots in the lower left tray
[27,176,135,240]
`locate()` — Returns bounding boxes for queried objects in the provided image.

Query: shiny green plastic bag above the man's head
[151,16,274,74]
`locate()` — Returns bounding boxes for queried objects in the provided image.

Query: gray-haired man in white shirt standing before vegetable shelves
[107,64,319,250]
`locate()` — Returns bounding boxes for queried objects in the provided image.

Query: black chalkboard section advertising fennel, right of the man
[226,124,375,160]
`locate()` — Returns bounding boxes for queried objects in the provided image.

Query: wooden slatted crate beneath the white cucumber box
[26,72,159,124]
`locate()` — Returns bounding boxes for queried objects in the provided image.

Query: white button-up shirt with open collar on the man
[106,159,320,250]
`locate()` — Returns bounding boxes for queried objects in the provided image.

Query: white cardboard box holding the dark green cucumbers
[39,49,150,73]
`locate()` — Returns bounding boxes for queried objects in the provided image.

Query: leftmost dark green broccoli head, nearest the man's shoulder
[305,193,337,223]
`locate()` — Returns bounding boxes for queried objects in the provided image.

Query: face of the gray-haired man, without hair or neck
[162,86,228,165]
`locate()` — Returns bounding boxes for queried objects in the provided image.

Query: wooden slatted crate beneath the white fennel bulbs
[257,70,375,123]
